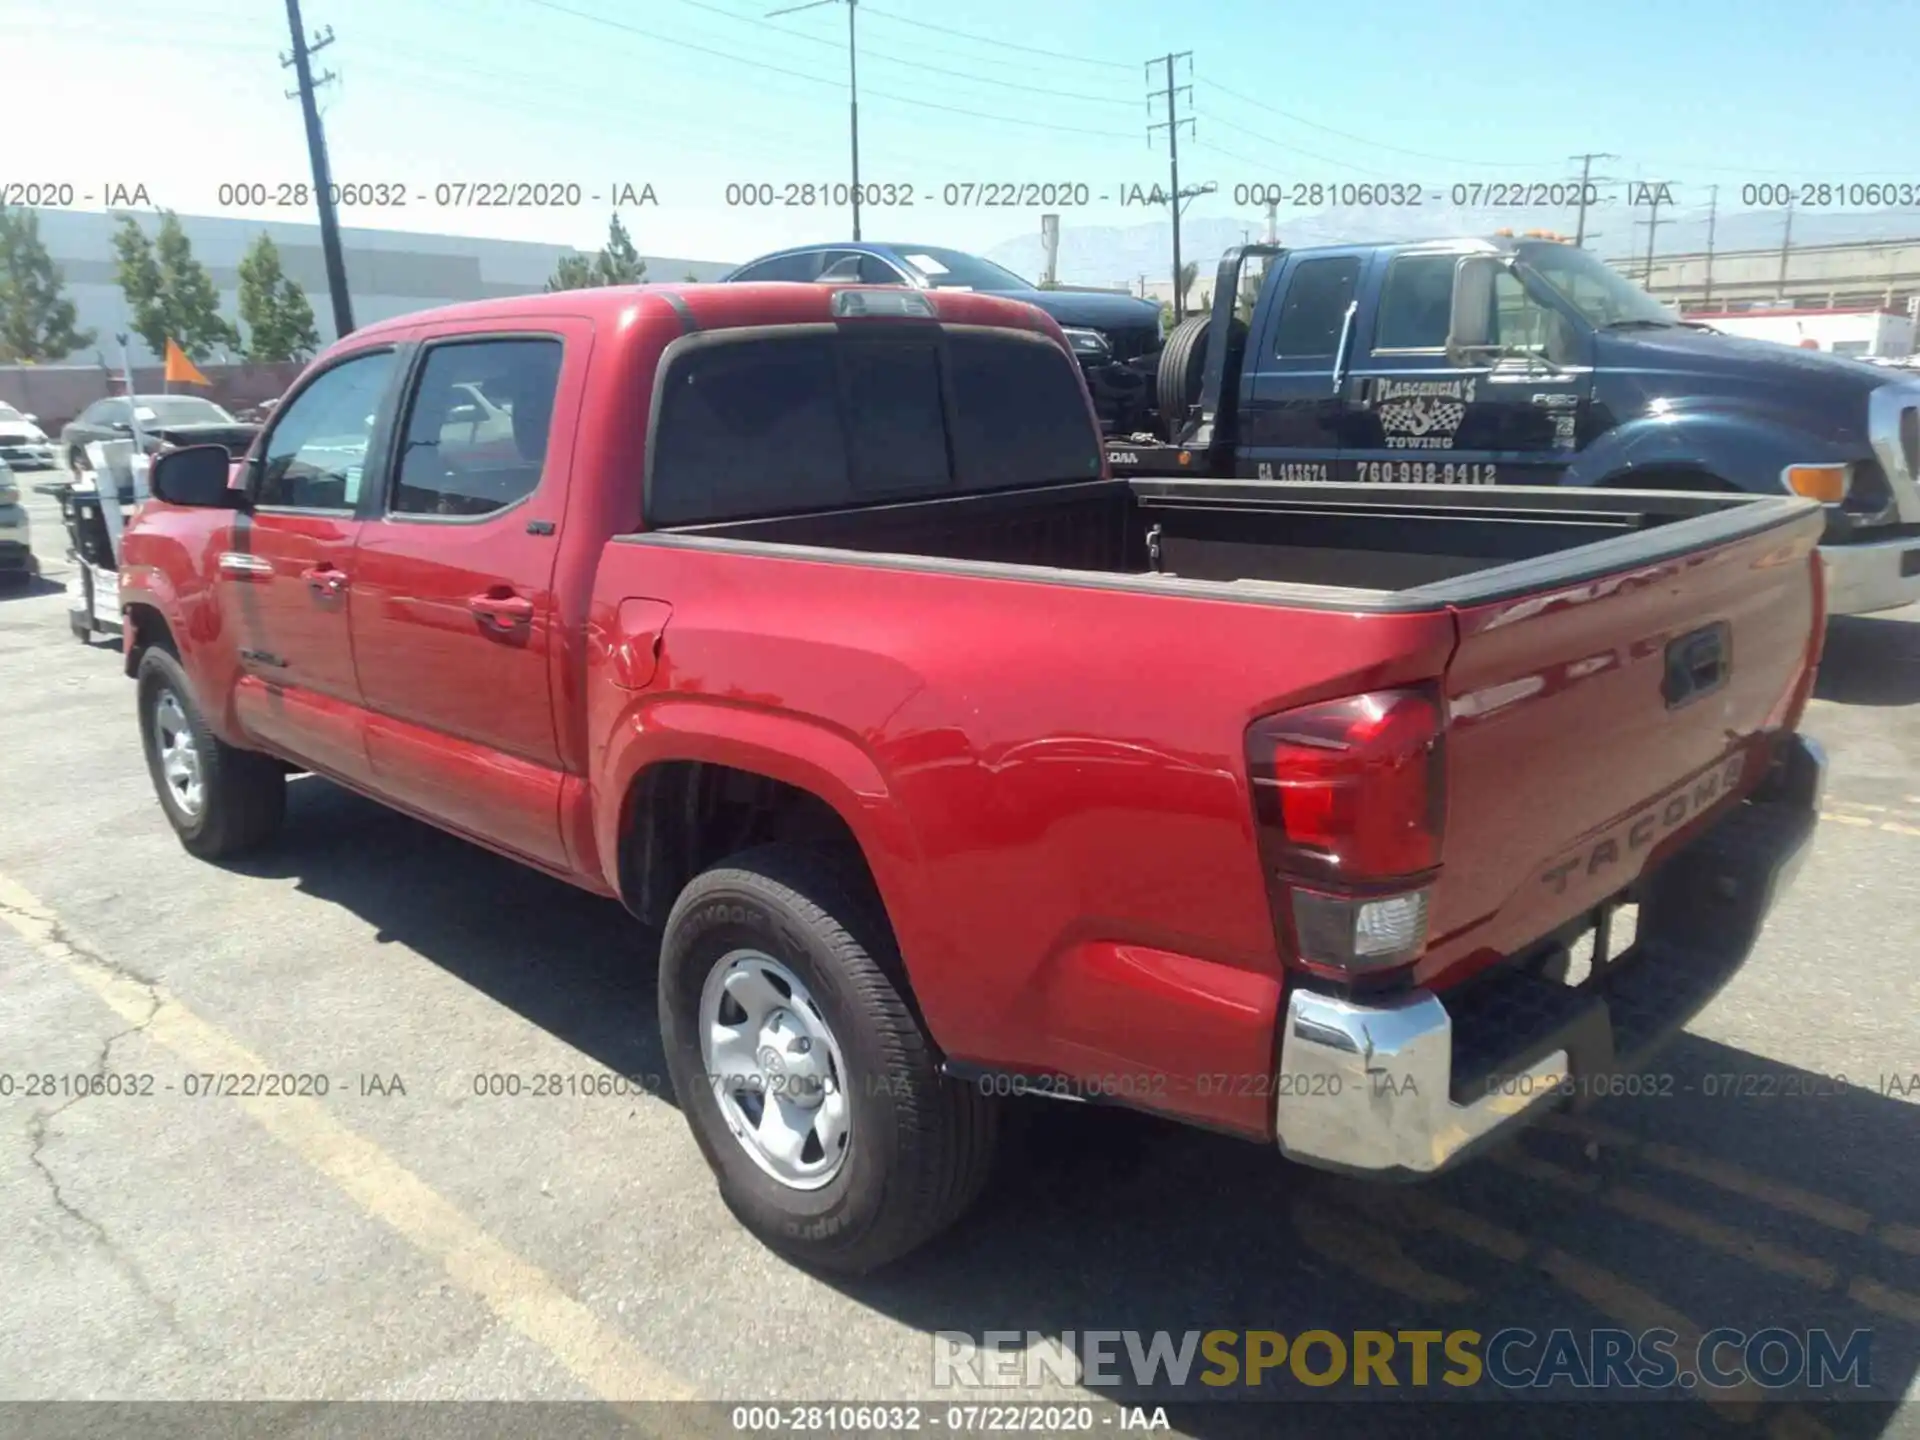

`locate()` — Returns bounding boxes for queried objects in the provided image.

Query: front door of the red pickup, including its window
[215,349,396,783]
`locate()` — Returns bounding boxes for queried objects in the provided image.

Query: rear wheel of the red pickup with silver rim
[660,845,996,1275]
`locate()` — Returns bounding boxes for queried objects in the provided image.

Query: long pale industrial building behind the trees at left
[22,209,732,365]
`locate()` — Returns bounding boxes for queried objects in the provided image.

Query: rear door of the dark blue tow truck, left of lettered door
[1236,250,1367,480]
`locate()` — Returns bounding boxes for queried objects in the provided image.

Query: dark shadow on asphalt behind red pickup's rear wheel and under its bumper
[841,1035,1920,1436]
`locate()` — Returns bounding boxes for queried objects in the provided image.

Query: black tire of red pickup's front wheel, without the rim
[138,645,286,860]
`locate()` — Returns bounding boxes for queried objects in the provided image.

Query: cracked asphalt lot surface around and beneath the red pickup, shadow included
[0,476,1920,1440]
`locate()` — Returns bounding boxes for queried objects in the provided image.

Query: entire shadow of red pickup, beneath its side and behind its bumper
[232,780,1920,1440]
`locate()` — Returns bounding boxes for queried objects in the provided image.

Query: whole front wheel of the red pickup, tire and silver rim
[138,645,286,860]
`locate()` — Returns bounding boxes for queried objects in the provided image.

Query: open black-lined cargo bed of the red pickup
[655,478,1807,609]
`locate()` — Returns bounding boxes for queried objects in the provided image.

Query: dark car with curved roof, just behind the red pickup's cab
[726,242,1160,434]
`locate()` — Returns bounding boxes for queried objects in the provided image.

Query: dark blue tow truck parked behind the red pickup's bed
[1108,238,1920,614]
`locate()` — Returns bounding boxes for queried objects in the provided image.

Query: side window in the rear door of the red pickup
[390,338,561,516]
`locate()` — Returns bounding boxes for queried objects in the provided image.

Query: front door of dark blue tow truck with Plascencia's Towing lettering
[1342,252,1592,486]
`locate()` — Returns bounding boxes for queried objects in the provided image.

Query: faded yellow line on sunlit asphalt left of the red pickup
[0,876,695,1402]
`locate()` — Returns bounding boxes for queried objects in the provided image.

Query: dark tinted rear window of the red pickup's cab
[647,332,1100,526]
